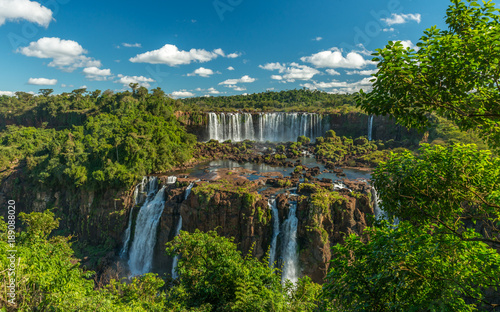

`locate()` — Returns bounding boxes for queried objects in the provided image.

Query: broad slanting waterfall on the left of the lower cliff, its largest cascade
[128,178,165,276]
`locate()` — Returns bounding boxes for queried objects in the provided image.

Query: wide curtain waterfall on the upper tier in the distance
[207,113,330,142]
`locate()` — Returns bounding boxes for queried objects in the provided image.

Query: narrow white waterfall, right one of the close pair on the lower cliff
[281,202,299,283]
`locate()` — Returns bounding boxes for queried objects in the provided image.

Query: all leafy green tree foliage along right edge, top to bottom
[324,0,500,311]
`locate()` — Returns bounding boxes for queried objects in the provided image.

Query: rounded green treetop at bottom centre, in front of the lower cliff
[167,230,320,312]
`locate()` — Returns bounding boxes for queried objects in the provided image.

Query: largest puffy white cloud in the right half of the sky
[301,48,372,68]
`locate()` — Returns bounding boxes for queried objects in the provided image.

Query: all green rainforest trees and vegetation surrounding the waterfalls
[0,0,500,311]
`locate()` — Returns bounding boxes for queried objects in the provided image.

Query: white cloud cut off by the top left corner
[0,0,53,28]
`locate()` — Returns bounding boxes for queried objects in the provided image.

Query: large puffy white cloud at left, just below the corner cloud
[17,37,101,72]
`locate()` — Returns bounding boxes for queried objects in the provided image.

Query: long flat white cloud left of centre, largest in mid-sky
[130,44,239,66]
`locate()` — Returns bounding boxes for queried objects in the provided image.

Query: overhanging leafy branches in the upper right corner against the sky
[358,0,500,148]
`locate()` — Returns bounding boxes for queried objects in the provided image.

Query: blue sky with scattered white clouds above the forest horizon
[0,0,456,98]
